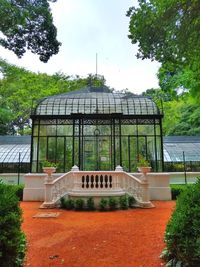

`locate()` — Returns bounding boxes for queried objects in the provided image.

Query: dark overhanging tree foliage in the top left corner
[0,0,61,62]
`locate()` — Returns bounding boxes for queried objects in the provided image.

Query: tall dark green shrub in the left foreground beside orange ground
[0,183,26,267]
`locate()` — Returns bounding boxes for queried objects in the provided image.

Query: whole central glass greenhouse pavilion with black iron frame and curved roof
[31,87,163,172]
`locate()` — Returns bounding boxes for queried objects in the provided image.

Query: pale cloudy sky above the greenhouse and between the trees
[0,0,159,93]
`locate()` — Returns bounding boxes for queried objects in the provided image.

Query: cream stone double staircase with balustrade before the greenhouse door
[42,166,153,208]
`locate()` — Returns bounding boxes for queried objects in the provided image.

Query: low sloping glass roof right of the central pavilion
[163,136,200,162]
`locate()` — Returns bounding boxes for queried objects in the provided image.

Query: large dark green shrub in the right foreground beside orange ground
[164,180,200,267]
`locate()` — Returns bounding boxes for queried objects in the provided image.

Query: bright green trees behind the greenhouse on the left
[0,60,105,134]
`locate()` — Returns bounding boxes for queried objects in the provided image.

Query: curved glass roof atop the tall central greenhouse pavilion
[34,87,160,115]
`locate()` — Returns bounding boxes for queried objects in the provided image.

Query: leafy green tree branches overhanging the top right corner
[127,0,200,96]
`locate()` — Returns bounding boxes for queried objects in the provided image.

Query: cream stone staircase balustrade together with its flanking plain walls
[23,166,171,208]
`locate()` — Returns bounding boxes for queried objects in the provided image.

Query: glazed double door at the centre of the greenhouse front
[83,136,111,171]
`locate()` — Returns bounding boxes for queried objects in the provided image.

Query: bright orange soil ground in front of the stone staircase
[21,201,175,267]
